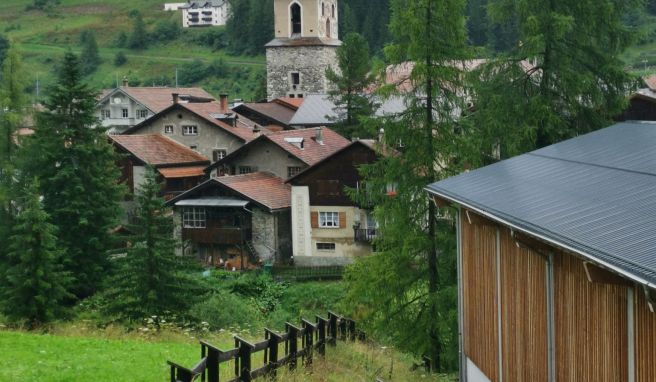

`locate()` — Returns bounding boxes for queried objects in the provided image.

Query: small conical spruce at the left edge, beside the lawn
[0,178,71,328]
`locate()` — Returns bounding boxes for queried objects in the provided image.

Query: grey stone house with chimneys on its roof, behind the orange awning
[124,96,257,162]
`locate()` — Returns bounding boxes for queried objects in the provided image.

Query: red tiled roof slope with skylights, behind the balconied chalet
[264,127,351,166]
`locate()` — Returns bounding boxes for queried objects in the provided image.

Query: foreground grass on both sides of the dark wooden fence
[0,325,454,382]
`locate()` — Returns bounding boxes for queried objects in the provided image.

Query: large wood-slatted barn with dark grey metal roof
[427,122,656,382]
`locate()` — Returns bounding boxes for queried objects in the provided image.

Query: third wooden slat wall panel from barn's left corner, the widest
[554,254,628,382]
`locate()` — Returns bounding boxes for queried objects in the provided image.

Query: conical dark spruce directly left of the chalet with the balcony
[107,168,199,319]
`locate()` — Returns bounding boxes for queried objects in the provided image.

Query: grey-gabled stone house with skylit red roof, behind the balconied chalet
[205,127,350,179]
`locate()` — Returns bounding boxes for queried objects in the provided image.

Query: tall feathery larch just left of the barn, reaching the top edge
[346,0,469,371]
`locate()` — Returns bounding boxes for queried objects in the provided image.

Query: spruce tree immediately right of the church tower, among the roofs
[326,33,374,138]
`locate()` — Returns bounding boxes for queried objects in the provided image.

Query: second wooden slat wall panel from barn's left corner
[500,228,549,382]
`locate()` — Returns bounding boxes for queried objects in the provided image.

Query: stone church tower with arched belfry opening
[266,0,341,100]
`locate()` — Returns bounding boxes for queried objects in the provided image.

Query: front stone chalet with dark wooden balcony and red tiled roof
[168,172,292,268]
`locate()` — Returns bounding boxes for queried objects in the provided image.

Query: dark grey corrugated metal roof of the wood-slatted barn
[427,122,656,285]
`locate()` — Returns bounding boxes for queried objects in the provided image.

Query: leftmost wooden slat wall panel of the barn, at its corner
[461,219,499,381]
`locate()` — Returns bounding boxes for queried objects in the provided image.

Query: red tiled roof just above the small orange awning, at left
[109,134,210,166]
